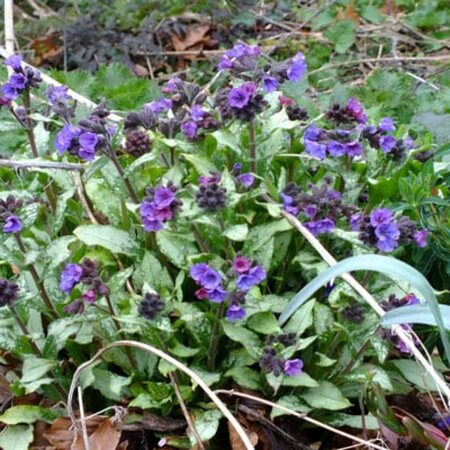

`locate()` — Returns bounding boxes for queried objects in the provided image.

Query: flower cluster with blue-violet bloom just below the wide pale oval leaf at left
[59,258,109,314]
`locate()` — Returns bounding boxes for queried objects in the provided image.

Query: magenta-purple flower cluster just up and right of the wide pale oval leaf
[139,182,182,232]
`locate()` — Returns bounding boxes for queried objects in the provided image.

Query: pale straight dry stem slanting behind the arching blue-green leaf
[263,194,450,409]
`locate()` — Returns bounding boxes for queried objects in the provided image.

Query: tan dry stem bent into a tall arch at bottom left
[67,340,255,450]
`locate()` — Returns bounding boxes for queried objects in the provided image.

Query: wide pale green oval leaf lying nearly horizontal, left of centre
[73,225,139,256]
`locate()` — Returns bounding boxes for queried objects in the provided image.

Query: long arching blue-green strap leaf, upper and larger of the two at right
[279,255,450,360]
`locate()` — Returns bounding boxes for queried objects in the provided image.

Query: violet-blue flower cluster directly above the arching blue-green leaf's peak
[350,208,429,252]
